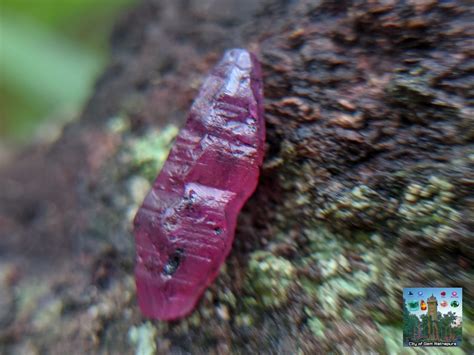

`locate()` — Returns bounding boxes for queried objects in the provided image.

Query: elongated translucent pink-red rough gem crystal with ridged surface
[134,49,265,320]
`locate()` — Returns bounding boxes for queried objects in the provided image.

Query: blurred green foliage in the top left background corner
[0,0,136,141]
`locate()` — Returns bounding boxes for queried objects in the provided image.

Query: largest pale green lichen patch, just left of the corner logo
[297,225,400,322]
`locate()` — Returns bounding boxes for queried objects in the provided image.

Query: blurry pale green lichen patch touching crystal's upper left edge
[129,125,178,181]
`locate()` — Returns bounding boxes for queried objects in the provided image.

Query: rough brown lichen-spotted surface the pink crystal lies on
[0,0,474,354]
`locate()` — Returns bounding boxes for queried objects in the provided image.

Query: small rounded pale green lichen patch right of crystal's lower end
[247,251,295,307]
